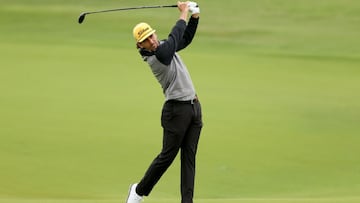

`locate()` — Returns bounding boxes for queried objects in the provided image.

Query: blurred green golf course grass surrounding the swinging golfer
[0,0,360,203]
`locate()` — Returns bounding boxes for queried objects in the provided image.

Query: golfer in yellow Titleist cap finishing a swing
[126,2,202,203]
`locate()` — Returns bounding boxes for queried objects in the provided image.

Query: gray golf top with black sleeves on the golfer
[140,18,199,101]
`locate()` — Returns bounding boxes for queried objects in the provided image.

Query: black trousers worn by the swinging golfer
[136,101,202,203]
